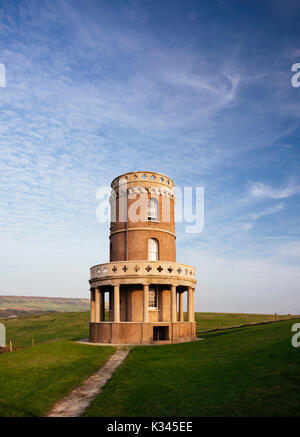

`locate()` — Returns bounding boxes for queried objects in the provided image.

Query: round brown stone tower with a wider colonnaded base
[89,171,196,344]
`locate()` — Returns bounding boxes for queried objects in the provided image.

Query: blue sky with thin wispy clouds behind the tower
[0,0,300,313]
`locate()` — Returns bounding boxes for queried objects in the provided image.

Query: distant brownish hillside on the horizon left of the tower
[0,296,89,318]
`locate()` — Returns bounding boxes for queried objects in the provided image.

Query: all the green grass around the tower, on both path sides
[0,313,300,417]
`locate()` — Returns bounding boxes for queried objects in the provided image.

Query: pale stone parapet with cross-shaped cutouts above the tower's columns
[90,261,195,281]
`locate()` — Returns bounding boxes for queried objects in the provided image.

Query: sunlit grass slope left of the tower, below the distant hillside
[1,312,90,347]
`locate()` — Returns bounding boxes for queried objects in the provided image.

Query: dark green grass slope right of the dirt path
[85,320,300,417]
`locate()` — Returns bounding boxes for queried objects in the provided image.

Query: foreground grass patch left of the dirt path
[0,341,115,417]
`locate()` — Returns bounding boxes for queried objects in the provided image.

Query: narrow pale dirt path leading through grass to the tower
[47,349,130,417]
